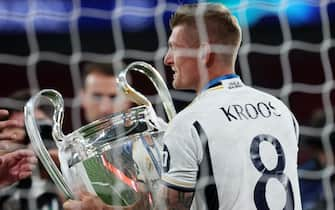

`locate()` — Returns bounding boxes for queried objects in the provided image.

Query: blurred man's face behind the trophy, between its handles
[81,71,130,122]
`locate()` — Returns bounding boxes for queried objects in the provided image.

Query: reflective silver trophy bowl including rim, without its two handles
[59,106,164,209]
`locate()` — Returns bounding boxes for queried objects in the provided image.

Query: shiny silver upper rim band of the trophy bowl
[63,105,164,166]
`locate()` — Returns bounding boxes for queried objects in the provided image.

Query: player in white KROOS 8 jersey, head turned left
[161,3,301,210]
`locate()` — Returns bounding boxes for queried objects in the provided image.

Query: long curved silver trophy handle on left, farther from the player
[24,89,75,199]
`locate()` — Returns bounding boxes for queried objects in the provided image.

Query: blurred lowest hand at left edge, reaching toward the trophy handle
[0,149,37,186]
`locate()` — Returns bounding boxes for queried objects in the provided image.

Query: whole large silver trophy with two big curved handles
[24,62,176,209]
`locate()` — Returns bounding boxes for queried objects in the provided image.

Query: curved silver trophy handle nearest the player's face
[117,61,176,121]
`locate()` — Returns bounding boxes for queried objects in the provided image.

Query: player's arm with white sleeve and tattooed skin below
[158,118,202,210]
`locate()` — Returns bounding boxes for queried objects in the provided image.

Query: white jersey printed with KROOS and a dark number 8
[162,76,301,210]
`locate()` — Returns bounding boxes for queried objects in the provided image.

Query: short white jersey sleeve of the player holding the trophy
[162,116,202,191]
